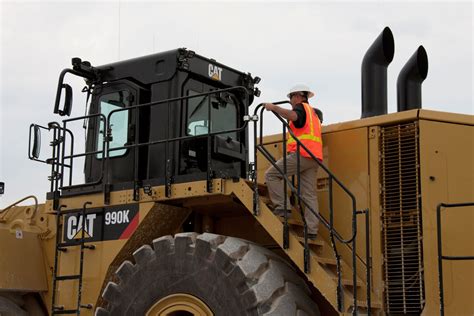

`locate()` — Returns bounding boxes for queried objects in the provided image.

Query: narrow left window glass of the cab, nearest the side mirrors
[97,91,130,159]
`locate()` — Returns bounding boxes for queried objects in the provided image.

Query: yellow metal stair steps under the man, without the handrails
[231,181,382,315]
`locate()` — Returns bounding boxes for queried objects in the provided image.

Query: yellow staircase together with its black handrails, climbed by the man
[243,101,383,315]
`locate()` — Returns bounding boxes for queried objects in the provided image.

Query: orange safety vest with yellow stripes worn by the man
[286,103,323,161]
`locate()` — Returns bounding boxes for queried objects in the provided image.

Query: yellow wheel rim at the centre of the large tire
[146,293,214,316]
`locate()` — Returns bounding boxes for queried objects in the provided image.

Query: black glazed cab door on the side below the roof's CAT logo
[179,79,246,178]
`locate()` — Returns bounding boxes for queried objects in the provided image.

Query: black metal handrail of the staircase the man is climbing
[253,101,371,315]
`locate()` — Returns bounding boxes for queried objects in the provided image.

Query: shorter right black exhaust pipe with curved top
[397,46,428,112]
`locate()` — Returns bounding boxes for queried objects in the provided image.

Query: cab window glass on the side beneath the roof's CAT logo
[187,90,237,140]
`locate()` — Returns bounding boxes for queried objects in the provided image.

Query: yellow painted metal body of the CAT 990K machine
[0,110,474,315]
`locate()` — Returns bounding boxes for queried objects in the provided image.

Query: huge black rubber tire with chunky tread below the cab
[96,233,319,316]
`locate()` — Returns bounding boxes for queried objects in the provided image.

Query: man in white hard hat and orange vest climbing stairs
[264,85,323,239]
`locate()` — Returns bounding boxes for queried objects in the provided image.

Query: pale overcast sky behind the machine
[0,0,474,208]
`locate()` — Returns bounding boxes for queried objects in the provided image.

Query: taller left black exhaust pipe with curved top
[362,27,395,118]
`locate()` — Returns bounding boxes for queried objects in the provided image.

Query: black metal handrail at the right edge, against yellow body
[436,202,474,316]
